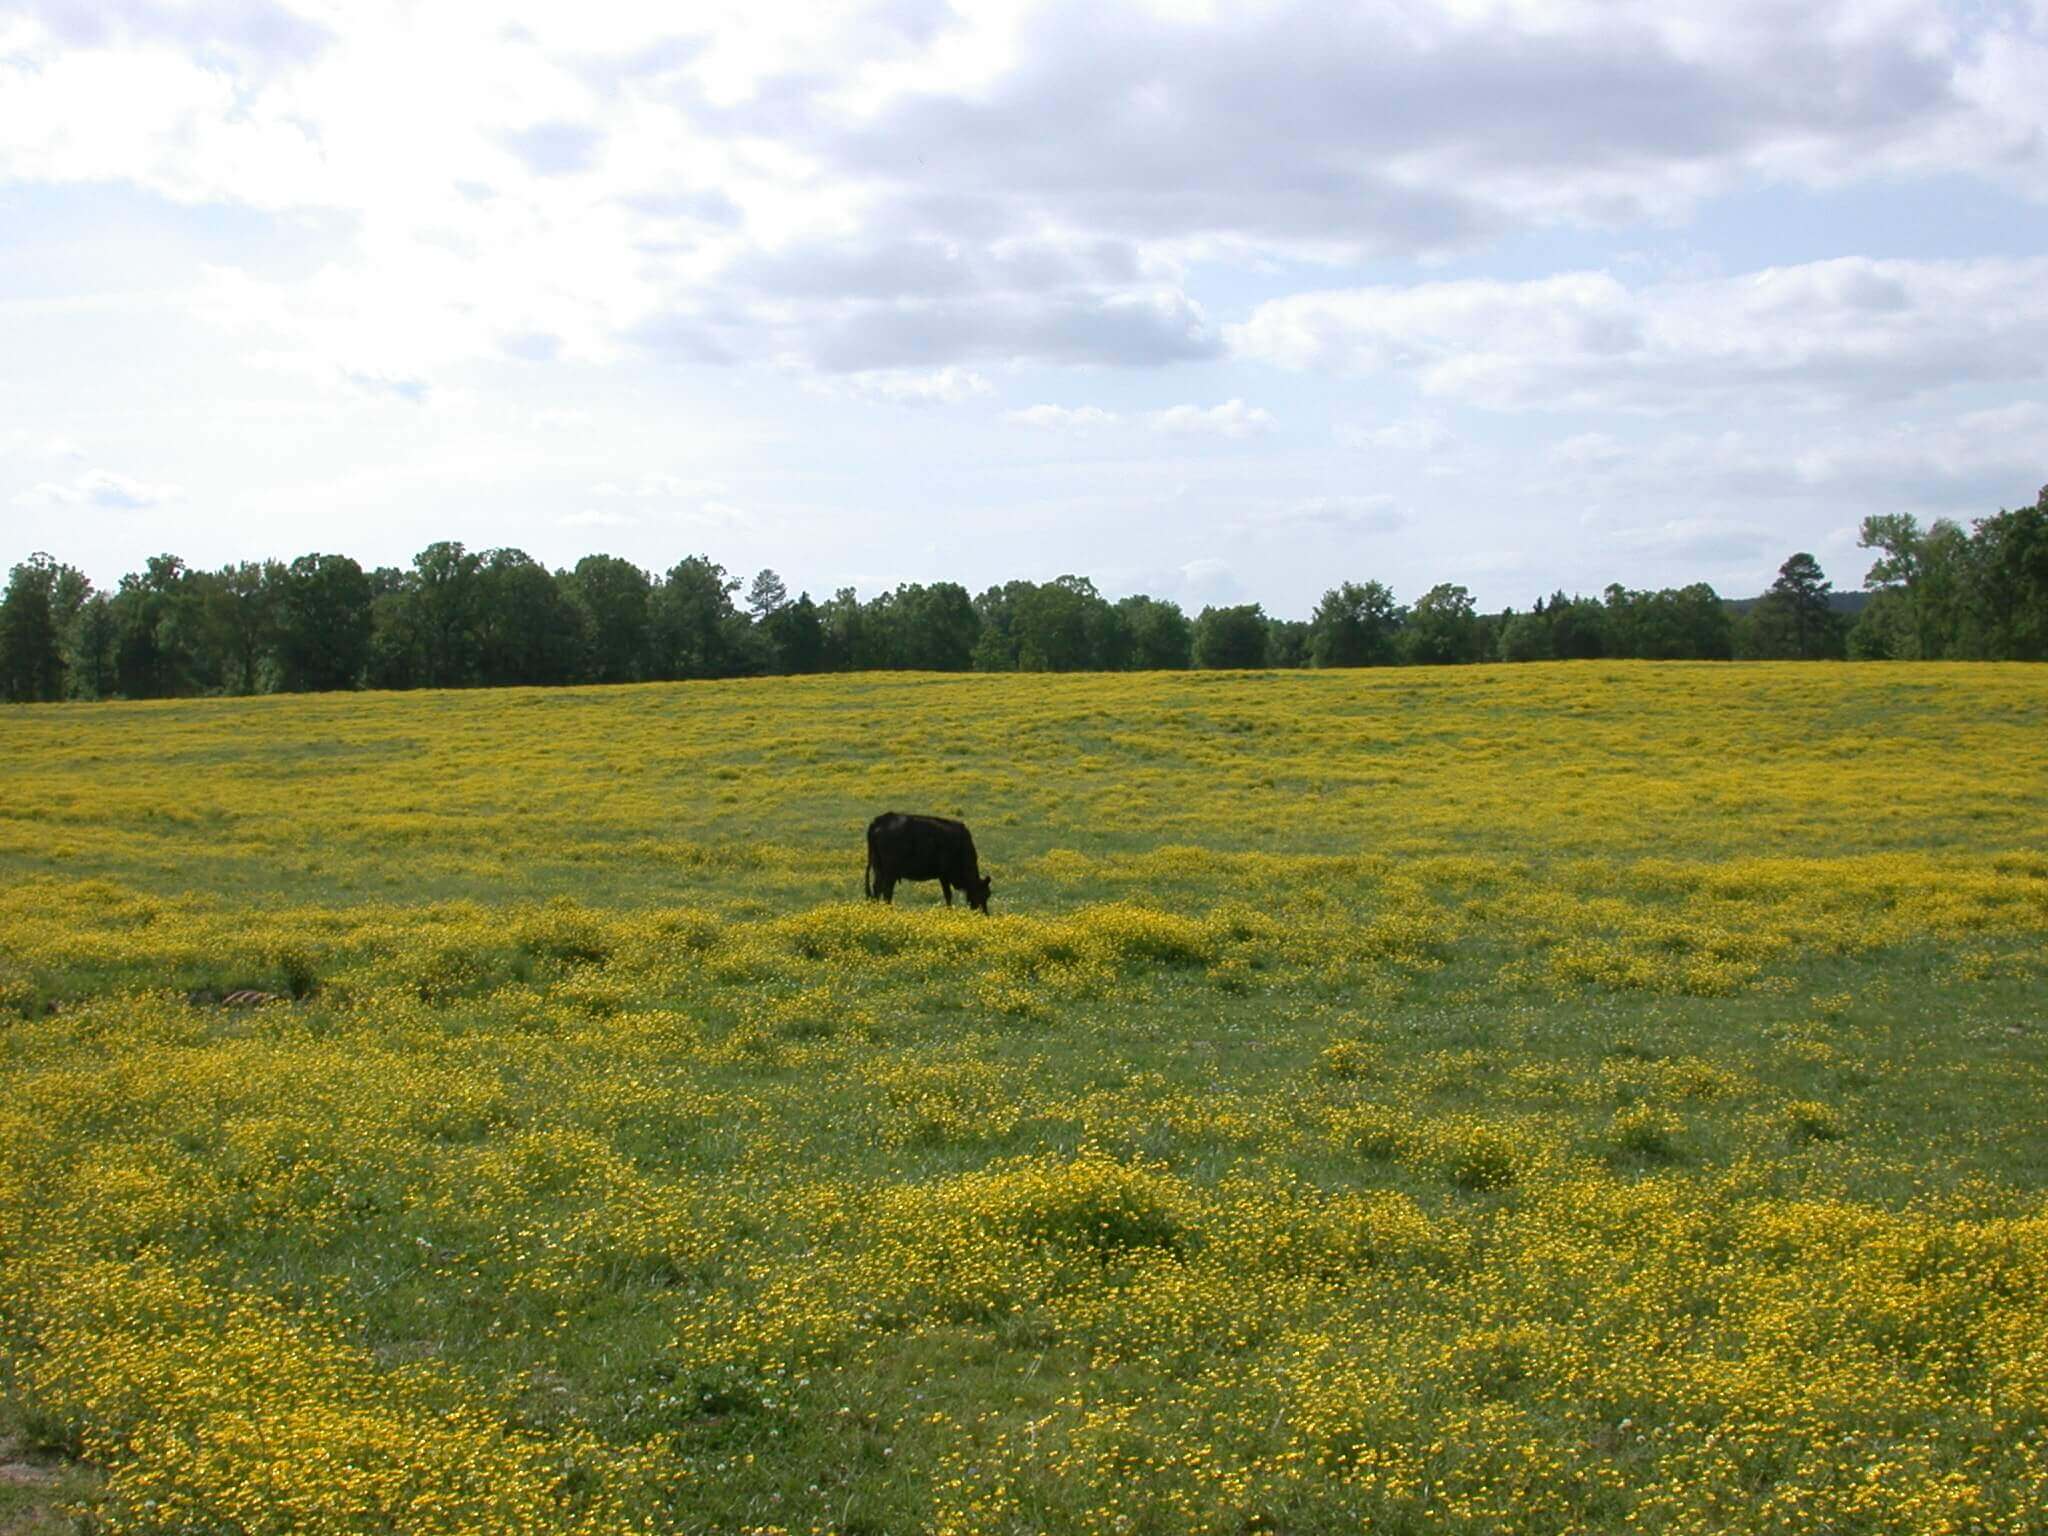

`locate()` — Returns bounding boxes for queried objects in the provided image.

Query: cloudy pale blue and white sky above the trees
[0,0,2048,616]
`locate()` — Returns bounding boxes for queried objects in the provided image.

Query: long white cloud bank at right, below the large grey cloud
[1227,256,2048,412]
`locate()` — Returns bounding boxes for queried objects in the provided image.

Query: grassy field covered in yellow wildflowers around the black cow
[0,664,2048,1536]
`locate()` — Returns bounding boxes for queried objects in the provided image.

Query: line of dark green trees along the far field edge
[0,487,2048,702]
